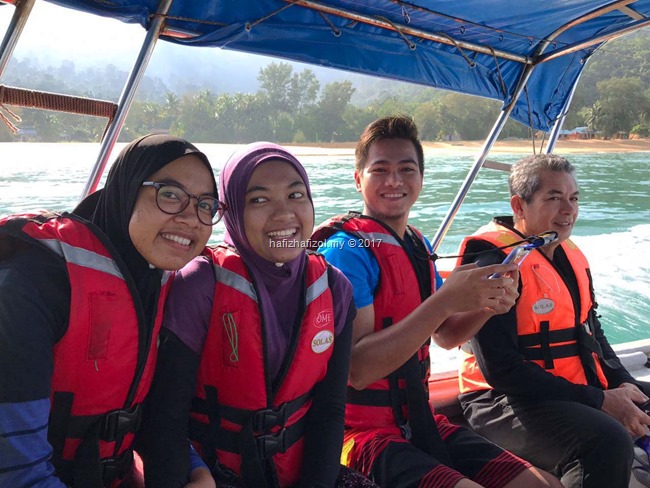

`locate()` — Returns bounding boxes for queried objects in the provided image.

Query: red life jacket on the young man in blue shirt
[312,212,435,430]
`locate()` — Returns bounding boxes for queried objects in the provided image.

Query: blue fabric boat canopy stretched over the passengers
[44,0,650,131]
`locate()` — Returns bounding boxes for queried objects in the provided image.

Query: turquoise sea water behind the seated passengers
[0,143,650,354]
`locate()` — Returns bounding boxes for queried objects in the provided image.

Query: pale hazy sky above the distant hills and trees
[0,0,364,93]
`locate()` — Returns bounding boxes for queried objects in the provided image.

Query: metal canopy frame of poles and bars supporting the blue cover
[0,0,650,250]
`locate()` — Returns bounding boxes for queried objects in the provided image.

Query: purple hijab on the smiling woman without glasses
[219,142,314,377]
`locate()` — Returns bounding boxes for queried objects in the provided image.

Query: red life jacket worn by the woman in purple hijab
[190,246,335,488]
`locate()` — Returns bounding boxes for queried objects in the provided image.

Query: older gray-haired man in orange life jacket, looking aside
[459,154,650,488]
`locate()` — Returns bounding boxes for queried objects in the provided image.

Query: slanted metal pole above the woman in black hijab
[81,0,173,199]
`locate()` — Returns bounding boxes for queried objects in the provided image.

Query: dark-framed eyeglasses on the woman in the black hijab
[142,181,226,225]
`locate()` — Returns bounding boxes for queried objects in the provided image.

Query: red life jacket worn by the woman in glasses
[0,214,172,487]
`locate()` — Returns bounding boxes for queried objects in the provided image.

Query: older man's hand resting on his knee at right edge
[601,383,650,437]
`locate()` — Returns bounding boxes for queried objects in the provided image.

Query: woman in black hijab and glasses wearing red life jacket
[0,135,222,488]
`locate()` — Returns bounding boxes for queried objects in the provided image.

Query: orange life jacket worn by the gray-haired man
[458,222,607,393]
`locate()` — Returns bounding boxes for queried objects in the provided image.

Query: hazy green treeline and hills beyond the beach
[0,31,650,143]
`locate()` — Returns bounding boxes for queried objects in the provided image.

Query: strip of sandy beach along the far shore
[286,139,650,156]
